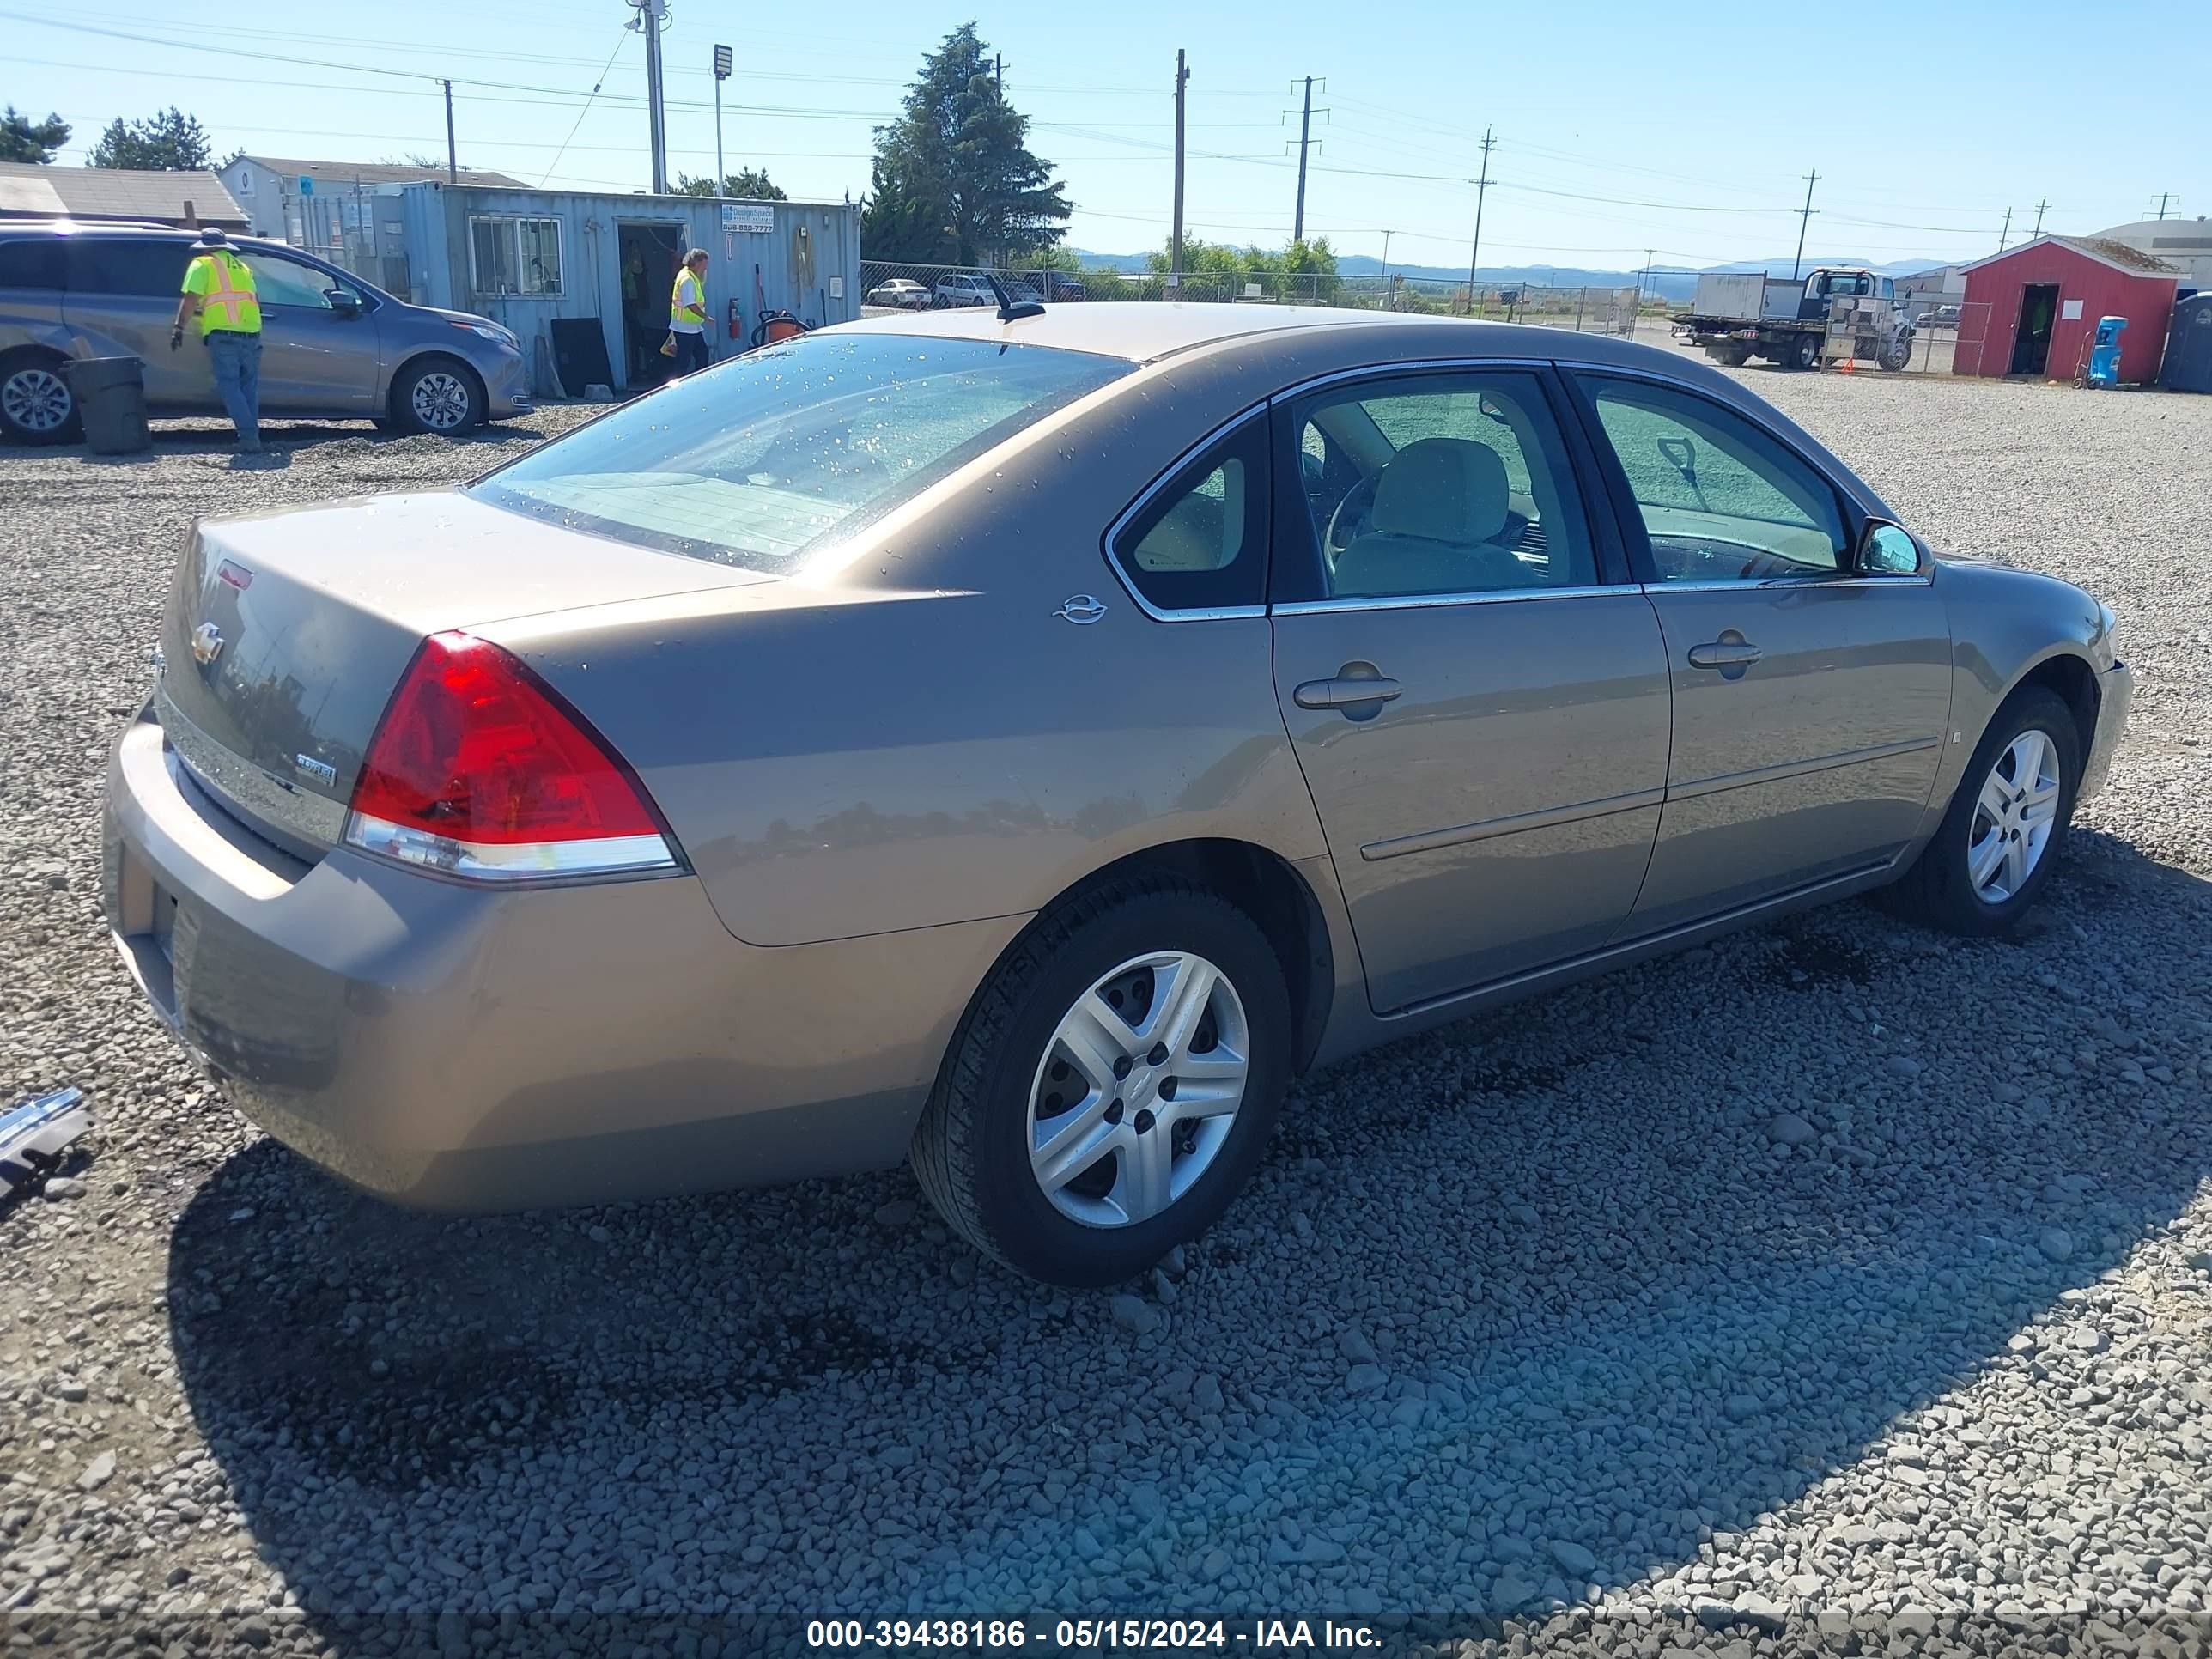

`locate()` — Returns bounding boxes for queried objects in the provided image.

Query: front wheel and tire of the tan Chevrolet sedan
[1893,686,2081,936]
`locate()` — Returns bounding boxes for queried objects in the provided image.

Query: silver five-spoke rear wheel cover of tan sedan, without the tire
[1029,951,1252,1228]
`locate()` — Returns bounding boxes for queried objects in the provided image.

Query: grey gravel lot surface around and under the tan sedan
[0,368,2212,1656]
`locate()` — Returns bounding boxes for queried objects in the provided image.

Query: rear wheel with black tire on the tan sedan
[911,876,1291,1287]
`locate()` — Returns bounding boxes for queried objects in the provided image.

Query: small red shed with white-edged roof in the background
[1951,237,2181,383]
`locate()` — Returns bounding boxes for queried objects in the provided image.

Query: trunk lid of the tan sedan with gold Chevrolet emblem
[155,491,775,858]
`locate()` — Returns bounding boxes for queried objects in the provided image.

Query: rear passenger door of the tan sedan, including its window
[1274,369,1668,1013]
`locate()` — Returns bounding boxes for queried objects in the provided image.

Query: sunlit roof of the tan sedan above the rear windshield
[841,301,1486,362]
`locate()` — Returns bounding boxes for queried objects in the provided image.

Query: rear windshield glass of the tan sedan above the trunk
[469,334,1134,575]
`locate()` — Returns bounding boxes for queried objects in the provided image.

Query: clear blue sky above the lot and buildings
[0,0,2212,268]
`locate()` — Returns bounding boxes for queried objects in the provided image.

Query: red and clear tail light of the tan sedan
[345,633,677,880]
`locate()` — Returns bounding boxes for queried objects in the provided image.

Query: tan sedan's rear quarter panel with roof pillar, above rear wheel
[480,347,1325,945]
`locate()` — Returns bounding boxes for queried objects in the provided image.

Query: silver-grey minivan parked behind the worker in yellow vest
[0,222,531,442]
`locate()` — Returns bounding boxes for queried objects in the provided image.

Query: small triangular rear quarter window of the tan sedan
[1113,416,1270,611]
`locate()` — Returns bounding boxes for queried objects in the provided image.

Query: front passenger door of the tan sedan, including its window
[1583,376,1951,933]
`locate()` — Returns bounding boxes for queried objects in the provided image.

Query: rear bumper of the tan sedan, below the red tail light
[104,717,1020,1210]
